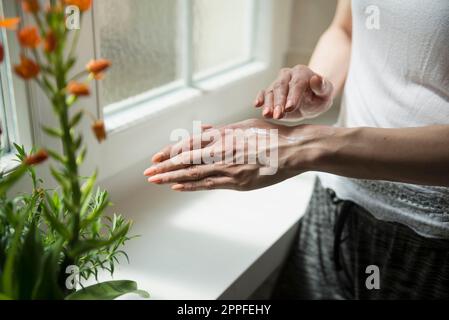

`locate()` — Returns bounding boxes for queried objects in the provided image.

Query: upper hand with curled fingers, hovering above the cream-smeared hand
[254,65,334,120]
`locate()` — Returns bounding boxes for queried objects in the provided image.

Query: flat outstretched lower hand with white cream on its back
[144,120,307,191]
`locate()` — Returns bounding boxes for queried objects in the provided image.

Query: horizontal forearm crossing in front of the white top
[293,126,449,187]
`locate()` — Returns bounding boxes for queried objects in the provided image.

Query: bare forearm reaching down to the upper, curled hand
[309,26,351,97]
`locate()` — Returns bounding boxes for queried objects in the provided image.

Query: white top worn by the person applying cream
[320,0,449,239]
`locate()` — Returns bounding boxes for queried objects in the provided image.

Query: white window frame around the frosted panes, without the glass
[31,0,292,179]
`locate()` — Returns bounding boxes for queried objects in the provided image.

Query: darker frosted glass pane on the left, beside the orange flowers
[95,0,181,106]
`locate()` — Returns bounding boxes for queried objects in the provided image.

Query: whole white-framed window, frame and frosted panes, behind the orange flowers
[15,0,291,180]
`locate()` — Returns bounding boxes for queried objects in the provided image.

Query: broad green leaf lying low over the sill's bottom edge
[65,280,150,300]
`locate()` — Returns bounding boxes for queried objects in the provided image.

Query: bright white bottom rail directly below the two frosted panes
[105,61,268,135]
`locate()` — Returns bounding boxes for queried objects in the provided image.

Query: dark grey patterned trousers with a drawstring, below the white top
[273,181,449,300]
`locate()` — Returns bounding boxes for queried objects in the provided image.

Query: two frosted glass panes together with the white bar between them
[94,0,257,115]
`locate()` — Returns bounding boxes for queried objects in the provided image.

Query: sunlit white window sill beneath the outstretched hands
[90,173,315,300]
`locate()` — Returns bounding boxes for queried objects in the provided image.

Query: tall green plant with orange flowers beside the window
[0,0,148,300]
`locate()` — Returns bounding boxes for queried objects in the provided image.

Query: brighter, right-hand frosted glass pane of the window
[193,0,254,73]
